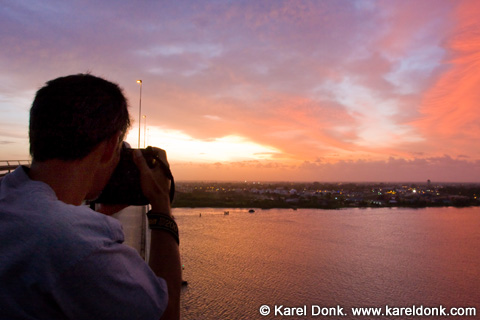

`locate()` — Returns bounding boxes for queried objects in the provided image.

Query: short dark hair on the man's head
[29,74,130,162]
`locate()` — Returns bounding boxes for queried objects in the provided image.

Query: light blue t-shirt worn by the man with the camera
[0,167,168,320]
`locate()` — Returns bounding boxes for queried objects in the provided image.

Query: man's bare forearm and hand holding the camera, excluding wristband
[134,149,182,319]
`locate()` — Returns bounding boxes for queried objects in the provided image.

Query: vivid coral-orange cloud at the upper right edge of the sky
[413,1,480,159]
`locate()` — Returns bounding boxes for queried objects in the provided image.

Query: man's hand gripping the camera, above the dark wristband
[133,148,170,215]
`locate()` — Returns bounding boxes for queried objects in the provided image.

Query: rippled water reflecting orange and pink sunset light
[174,208,480,319]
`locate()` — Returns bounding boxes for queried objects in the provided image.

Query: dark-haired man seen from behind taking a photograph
[0,74,181,320]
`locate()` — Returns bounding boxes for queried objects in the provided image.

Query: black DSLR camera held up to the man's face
[94,142,175,206]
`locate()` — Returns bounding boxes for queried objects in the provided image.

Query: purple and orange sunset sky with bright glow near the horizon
[0,0,480,182]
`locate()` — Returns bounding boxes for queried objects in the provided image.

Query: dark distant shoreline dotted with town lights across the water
[173,182,480,209]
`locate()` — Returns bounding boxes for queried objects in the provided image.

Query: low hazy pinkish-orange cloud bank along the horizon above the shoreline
[171,156,480,182]
